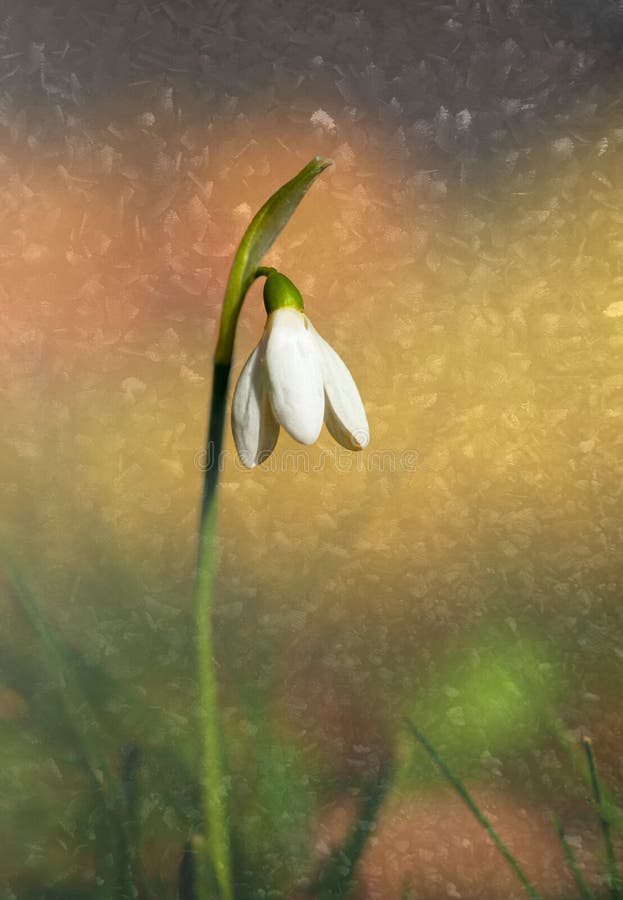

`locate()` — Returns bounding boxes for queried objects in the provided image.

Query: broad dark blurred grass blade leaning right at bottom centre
[312,765,393,900]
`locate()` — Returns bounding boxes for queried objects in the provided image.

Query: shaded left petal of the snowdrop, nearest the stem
[231,336,279,469]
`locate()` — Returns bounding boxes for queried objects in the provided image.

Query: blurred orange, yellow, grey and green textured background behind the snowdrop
[0,0,623,900]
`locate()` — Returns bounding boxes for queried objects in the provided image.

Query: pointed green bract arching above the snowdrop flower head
[215,156,332,365]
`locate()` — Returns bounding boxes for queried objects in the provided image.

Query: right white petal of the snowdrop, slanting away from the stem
[309,323,370,450]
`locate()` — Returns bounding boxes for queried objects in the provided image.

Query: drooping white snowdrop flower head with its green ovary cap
[232,271,370,468]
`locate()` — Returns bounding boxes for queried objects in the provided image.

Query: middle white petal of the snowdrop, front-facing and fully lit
[266,307,324,444]
